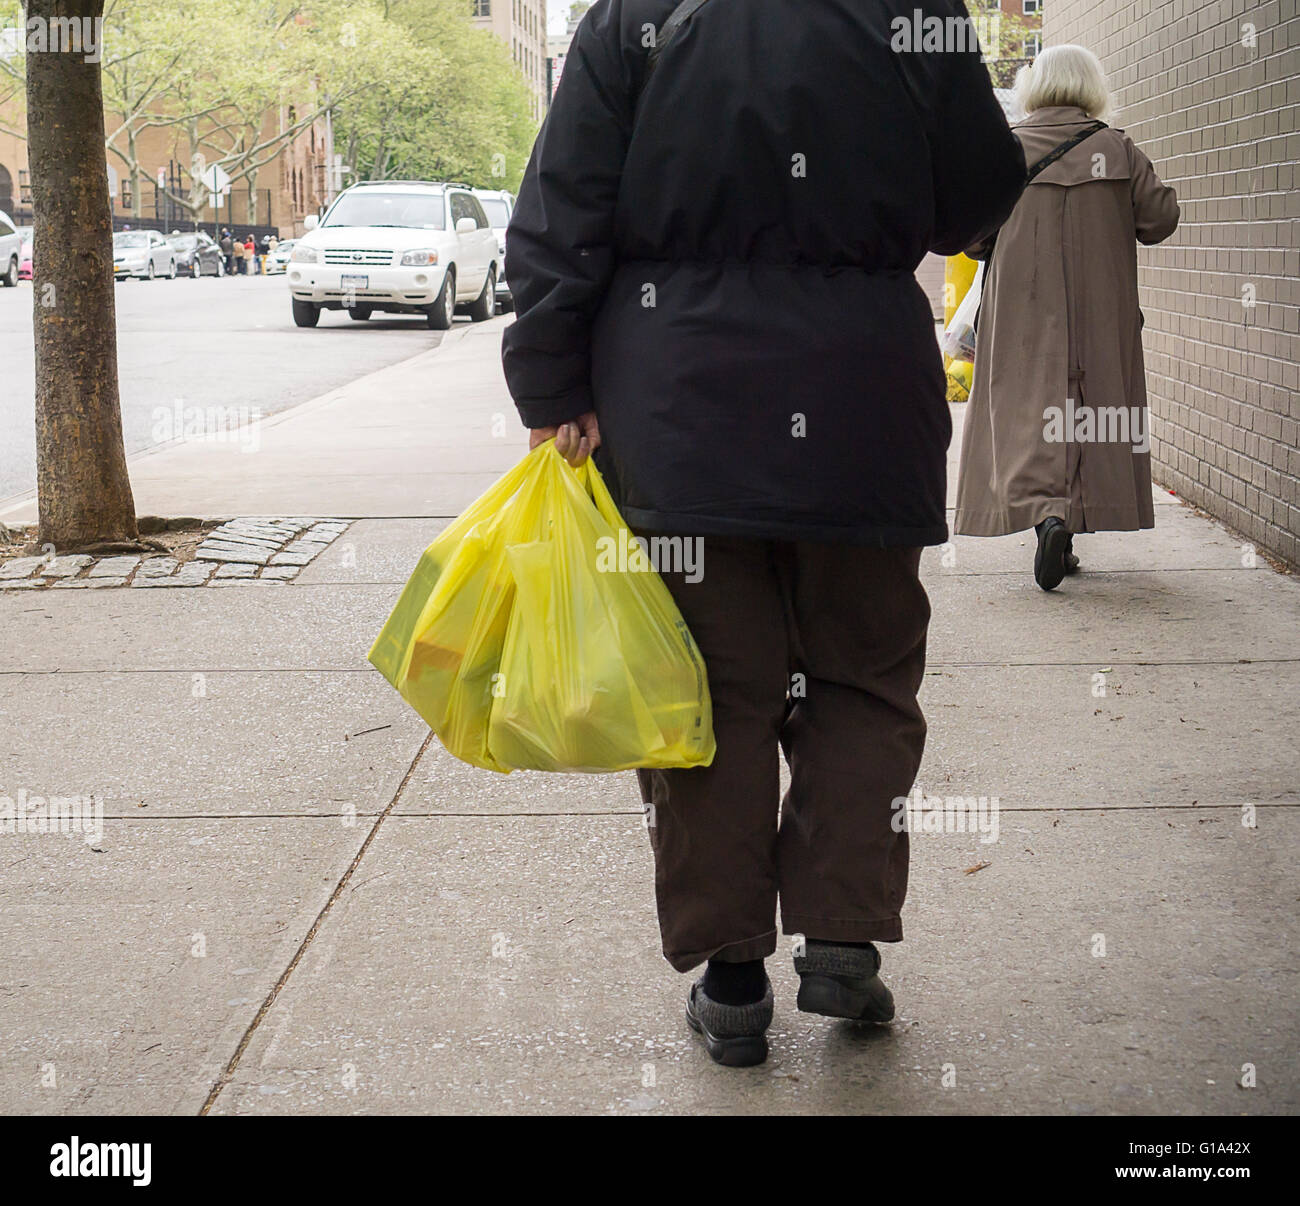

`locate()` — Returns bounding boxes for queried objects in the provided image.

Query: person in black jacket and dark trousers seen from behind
[503,0,1024,1064]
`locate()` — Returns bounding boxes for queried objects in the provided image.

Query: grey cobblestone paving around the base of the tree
[0,516,352,591]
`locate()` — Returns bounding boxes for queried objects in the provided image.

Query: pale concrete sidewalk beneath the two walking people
[0,321,1300,1114]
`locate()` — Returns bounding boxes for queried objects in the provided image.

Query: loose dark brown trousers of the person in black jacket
[638,533,930,972]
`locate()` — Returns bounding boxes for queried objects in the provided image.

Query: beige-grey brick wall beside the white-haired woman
[1044,0,1300,565]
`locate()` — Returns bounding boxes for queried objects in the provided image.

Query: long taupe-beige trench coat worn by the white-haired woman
[953,107,1178,535]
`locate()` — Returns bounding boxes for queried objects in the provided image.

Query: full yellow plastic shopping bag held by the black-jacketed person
[371,441,715,771]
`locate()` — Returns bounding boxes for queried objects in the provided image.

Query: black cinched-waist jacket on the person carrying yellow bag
[503,0,1024,545]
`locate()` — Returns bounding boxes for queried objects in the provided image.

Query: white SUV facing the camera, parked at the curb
[286,181,501,330]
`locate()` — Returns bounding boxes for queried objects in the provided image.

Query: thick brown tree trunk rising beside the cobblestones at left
[27,0,139,550]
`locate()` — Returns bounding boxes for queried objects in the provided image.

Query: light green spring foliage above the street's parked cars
[0,0,537,193]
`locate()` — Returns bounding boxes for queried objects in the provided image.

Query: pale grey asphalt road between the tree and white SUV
[0,276,447,503]
